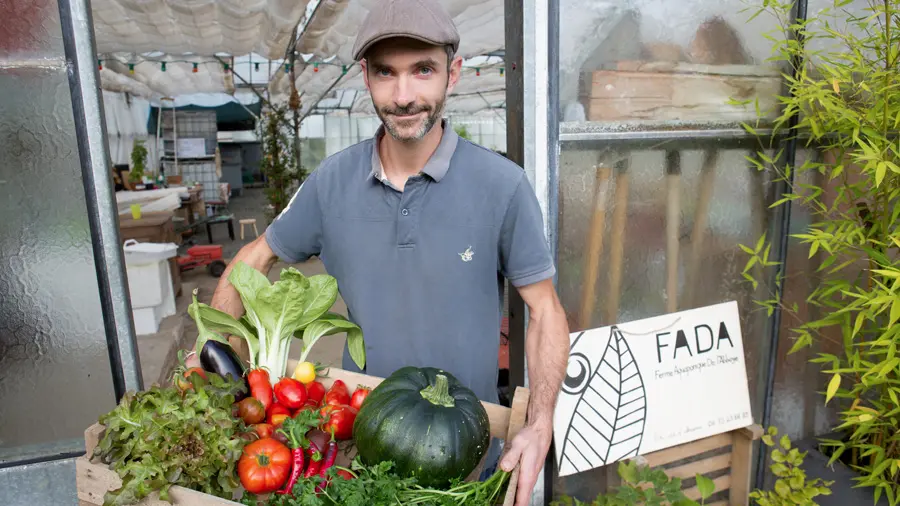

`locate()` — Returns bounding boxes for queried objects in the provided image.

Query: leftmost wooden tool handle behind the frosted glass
[578,165,612,330]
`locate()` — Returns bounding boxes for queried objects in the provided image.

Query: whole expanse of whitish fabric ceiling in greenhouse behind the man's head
[93,0,505,114]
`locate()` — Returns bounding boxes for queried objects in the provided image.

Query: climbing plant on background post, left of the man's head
[258,104,302,223]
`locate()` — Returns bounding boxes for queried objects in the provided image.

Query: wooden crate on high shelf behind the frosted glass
[580,61,782,121]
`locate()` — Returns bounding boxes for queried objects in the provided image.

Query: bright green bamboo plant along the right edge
[743,0,900,505]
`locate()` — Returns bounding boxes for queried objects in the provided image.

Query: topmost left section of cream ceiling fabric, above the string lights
[91,0,309,58]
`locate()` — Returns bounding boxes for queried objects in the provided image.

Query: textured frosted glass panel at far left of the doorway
[0,0,115,462]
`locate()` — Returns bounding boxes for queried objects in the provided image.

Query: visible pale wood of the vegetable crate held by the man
[75,368,529,506]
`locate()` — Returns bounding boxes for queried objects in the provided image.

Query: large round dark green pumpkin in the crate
[353,367,491,487]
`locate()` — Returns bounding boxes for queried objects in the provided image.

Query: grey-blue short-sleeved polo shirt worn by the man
[265,125,555,402]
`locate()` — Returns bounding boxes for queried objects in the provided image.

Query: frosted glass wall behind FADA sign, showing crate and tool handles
[553,0,781,500]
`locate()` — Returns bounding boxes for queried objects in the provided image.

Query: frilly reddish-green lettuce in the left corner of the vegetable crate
[94,373,246,506]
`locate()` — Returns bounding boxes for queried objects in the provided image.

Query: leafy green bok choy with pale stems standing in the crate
[188,262,366,384]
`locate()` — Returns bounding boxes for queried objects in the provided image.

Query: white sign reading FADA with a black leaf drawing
[553,302,753,476]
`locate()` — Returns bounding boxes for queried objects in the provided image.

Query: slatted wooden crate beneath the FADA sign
[634,425,763,506]
